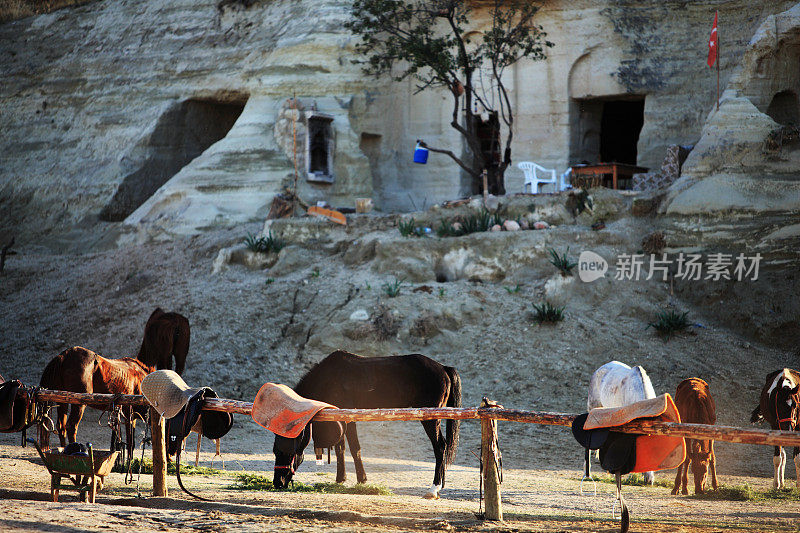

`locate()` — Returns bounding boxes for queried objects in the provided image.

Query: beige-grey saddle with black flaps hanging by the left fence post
[142,370,233,501]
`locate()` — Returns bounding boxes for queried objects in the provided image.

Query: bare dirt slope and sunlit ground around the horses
[0,197,800,532]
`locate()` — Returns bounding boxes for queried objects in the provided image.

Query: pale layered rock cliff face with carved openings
[0,0,792,234]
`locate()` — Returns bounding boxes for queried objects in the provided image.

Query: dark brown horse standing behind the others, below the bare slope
[136,307,189,375]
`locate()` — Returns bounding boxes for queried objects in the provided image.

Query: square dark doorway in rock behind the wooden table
[570,97,644,165]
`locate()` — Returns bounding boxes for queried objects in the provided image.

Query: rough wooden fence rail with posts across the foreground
[29,389,800,519]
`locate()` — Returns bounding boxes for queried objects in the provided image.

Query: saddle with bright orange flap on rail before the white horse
[572,394,686,533]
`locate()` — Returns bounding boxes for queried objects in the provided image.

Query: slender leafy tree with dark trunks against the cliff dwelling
[347,0,553,195]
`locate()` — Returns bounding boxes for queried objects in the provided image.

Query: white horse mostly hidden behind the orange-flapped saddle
[586,361,656,485]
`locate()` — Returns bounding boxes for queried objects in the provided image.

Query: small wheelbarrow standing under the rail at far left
[27,439,119,503]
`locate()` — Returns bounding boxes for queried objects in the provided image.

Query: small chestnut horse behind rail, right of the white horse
[672,378,717,494]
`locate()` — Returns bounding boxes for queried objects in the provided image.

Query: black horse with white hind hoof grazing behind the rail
[273,350,461,498]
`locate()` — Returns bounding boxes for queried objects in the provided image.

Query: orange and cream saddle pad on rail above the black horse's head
[251,383,338,436]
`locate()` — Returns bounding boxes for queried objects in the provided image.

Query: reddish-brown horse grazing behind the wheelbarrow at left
[39,346,154,457]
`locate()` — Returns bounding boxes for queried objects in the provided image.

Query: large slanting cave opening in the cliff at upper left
[100,96,247,222]
